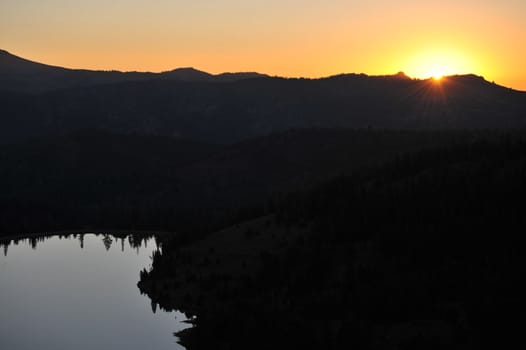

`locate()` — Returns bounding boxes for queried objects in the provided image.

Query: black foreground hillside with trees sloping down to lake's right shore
[139,137,526,350]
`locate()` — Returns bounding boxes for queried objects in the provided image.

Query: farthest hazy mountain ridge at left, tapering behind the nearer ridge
[0,50,265,93]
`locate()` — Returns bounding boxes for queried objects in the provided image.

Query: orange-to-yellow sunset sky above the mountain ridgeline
[0,0,526,90]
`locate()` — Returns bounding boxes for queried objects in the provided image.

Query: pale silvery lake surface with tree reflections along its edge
[0,234,188,350]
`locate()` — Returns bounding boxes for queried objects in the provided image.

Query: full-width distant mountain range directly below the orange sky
[0,51,526,143]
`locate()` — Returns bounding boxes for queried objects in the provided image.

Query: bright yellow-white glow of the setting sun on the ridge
[405,50,477,81]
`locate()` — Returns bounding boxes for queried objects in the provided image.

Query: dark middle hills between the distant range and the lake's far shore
[0,129,482,234]
